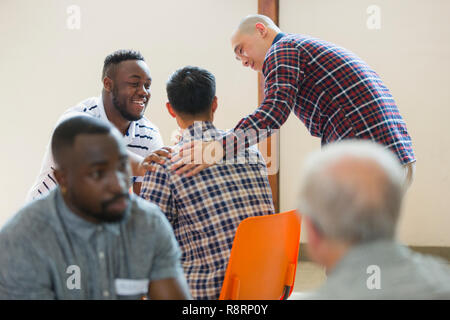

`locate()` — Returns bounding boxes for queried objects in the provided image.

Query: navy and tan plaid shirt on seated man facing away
[141,122,274,300]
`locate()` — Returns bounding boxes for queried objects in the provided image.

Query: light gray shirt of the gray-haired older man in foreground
[309,240,450,300]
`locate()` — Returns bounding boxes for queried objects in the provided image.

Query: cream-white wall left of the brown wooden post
[0,0,257,226]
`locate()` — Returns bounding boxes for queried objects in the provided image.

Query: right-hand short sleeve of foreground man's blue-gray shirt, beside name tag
[149,209,185,281]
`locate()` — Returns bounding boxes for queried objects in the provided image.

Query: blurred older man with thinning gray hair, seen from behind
[298,140,450,299]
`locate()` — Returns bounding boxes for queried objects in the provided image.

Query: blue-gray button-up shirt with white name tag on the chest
[0,188,184,299]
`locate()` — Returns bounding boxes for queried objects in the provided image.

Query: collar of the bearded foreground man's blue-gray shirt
[55,187,124,241]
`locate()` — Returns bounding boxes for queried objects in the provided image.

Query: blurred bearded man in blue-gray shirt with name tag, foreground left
[0,115,190,299]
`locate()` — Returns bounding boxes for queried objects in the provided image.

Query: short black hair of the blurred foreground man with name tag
[51,115,113,165]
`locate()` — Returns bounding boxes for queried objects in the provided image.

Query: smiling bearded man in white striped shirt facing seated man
[28,50,168,200]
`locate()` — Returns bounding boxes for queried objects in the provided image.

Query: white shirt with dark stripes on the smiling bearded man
[27,96,164,201]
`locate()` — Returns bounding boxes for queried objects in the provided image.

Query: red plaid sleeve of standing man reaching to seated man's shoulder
[223,42,302,155]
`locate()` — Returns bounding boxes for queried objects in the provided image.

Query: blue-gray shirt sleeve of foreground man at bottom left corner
[0,233,55,300]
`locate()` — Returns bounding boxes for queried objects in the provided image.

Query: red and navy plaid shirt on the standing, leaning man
[230,34,415,164]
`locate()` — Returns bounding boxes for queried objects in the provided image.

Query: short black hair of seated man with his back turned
[166,66,216,116]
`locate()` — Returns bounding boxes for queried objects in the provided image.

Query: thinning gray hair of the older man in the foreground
[298,140,404,243]
